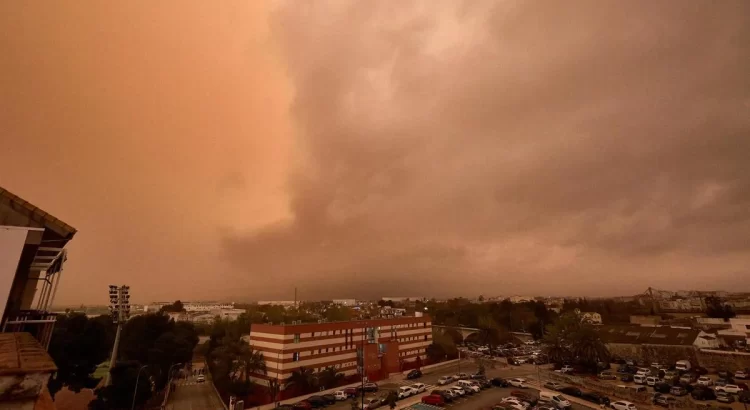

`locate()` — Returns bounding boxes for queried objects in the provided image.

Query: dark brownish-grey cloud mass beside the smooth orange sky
[224,1,750,297]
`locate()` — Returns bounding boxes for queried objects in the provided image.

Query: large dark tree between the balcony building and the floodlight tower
[48,313,115,397]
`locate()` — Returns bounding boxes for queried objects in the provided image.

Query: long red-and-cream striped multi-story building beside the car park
[250,314,432,386]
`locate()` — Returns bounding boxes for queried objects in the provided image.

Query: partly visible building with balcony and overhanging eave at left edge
[0,187,76,409]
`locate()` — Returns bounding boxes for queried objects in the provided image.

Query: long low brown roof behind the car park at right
[597,325,700,346]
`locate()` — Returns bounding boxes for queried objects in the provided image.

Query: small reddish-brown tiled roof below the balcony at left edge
[0,333,57,375]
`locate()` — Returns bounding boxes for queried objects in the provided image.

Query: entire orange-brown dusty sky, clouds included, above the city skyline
[0,0,750,303]
